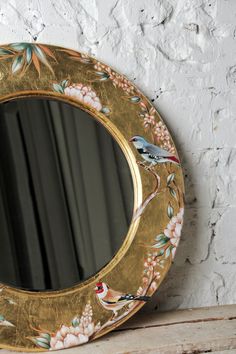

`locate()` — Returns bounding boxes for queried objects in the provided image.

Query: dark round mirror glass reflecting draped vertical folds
[0,98,133,290]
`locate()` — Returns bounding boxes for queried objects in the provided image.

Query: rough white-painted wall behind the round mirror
[0,0,236,310]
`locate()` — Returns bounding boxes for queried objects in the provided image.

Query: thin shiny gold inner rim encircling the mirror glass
[0,90,142,297]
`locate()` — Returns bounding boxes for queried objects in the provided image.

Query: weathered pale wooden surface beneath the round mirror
[1,305,236,354]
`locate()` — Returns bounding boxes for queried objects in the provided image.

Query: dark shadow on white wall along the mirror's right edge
[141,124,200,312]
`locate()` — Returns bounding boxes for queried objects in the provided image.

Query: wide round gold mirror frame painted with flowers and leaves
[0,43,184,351]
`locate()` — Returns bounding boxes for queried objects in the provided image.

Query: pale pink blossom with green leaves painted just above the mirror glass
[53,80,109,114]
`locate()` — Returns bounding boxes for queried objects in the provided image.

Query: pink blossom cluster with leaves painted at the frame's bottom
[29,303,101,350]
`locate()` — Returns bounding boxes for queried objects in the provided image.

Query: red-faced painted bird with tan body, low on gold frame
[95,283,150,317]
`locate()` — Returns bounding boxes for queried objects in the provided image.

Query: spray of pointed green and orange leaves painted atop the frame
[0,43,56,76]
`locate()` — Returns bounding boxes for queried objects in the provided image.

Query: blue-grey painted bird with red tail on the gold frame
[130,135,180,167]
